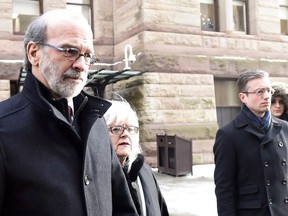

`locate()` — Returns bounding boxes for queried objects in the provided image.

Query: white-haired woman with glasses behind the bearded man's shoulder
[104,100,169,216]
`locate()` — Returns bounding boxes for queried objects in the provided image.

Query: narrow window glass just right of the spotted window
[233,0,246,32]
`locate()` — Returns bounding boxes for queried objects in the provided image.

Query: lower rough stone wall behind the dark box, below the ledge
[107,72,218,166]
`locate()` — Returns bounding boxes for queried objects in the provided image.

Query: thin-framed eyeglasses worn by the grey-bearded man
[38,43,99,65]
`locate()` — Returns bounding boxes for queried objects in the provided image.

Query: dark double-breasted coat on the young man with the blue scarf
[214,113,288,216]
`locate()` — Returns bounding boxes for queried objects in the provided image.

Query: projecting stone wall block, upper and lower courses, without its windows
[109,0,288,164]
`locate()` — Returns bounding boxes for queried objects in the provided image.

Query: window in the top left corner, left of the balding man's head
[12,0,40,34]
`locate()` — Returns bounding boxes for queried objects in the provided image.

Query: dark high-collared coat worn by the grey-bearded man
[0,72,136,216]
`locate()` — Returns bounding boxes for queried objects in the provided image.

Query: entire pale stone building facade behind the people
[0,0,288,166]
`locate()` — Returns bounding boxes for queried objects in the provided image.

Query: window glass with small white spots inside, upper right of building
[200,0,216,31]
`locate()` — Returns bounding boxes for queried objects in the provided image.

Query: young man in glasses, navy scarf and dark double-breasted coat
[213,71,288,216]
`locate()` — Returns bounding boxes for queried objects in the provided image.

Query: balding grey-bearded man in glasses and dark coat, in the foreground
[0,10,137,216]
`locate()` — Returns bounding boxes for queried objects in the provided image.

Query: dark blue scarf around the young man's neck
[241,104,271,132]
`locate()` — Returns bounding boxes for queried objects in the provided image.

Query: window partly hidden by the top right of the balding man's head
[66,0,92,25]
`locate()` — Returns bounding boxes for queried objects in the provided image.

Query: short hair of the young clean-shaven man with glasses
[237,70,269,93]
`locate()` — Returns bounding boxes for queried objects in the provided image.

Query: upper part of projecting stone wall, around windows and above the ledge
[114,0,288,78]
